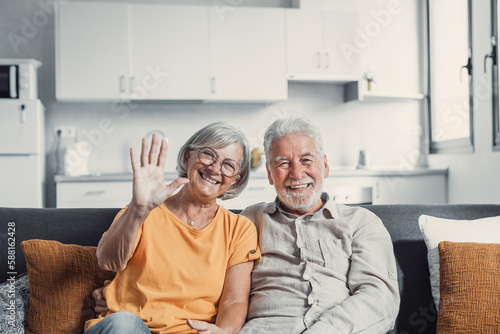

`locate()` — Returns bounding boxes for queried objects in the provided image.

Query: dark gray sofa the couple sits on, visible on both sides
[0,205,500,334]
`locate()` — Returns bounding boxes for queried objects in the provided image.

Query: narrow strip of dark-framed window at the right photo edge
[490,0,500,151]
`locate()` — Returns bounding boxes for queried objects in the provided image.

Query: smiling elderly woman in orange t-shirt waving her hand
[85,123,260,334]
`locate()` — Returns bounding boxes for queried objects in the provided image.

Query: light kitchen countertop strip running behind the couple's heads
[54,166,448,183]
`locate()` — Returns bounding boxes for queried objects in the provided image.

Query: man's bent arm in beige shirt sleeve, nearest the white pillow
[304,218,400,334]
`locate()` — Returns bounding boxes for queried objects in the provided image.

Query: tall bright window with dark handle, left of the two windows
[427,0,474,153]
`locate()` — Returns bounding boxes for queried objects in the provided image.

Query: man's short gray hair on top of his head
[264,115,325,166]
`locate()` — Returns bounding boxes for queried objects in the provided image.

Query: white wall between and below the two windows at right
[429,0,500,204]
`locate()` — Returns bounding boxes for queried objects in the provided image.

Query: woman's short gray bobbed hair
[176,122,250,199]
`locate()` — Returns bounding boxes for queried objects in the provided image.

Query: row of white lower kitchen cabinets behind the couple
[55,168,448,210]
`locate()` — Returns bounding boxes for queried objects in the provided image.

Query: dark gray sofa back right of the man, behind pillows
[363,204,500,334]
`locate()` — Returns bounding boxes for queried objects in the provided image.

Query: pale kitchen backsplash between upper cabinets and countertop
[48,83,422,174]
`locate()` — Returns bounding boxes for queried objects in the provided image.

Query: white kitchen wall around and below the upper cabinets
[0,0,425,206]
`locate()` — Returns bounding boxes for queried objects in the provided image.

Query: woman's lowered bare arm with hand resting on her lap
[188,261,254,334]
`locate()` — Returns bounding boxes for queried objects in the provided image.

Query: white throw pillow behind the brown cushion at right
[418,215,500,308]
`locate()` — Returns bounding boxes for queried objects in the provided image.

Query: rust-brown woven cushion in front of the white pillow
[437,241,500,334]
